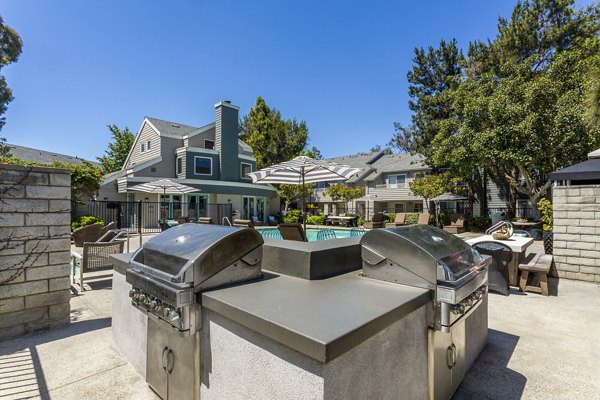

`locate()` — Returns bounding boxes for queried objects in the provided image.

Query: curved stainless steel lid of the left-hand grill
[131,223,263,286]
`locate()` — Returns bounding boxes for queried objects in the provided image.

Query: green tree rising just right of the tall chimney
[240,97,308,169]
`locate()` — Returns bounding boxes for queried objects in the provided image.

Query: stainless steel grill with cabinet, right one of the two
[361,225,491,399]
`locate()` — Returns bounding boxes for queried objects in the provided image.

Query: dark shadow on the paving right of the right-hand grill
[453,329,527,400]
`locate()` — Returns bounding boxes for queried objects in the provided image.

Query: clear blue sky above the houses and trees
[0,0,587,160]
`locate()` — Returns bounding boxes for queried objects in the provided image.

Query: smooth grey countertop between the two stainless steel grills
[111,253,431,363]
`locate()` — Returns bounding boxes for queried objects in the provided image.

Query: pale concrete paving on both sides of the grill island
[0,236,600,400]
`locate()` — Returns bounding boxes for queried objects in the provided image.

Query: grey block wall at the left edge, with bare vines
[0,164,71,339]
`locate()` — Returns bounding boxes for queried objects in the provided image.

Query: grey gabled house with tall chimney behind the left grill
[98,101,279,222]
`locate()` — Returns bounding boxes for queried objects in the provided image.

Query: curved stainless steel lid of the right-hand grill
[360,225,483,288]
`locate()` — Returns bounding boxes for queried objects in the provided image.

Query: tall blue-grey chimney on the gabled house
[215,100,240,181]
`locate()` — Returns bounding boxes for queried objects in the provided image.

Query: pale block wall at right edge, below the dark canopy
[552,185,600,283]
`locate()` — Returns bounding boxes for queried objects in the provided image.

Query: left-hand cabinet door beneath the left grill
[146,318,169,399]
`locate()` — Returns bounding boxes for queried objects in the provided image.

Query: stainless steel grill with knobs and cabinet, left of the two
[126,224,263,399]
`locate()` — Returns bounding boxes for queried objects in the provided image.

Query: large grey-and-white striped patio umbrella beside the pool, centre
[248,156,362,230]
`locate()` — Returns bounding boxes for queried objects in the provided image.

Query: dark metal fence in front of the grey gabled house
[88,200,232,233]
